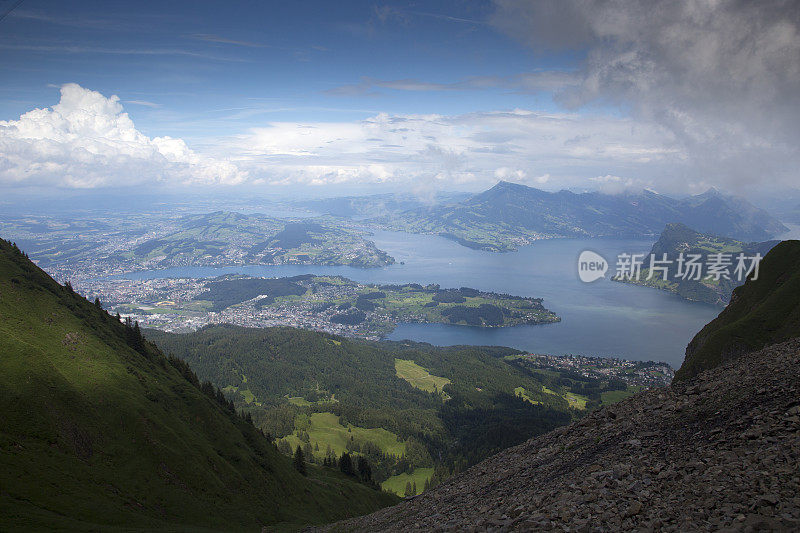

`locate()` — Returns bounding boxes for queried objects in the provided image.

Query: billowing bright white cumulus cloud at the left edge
[0,84,247,188]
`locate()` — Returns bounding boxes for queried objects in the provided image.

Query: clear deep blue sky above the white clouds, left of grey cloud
[0,0,564,138]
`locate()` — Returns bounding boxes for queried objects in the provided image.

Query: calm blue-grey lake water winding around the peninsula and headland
[115,232,719,367]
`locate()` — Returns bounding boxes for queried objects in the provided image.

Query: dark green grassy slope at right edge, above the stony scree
[675,241,800,380]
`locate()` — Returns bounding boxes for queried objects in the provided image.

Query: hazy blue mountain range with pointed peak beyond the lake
[375,181,788,252]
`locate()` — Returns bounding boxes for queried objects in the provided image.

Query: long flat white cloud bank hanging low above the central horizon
[217,110,681,188]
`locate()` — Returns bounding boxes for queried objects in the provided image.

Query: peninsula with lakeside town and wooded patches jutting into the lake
[75,274,560,340]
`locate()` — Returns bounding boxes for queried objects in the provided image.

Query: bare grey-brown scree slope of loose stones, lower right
[322,339,800,531]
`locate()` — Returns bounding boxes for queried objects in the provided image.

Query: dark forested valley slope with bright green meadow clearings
[146,326,636,493]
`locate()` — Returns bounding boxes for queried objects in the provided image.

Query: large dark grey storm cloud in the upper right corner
[491,0,800,188]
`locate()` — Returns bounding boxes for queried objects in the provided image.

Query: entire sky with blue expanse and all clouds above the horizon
[0,0,800,195]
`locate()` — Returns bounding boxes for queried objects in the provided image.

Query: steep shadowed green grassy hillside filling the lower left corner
[0,241,393,531]
